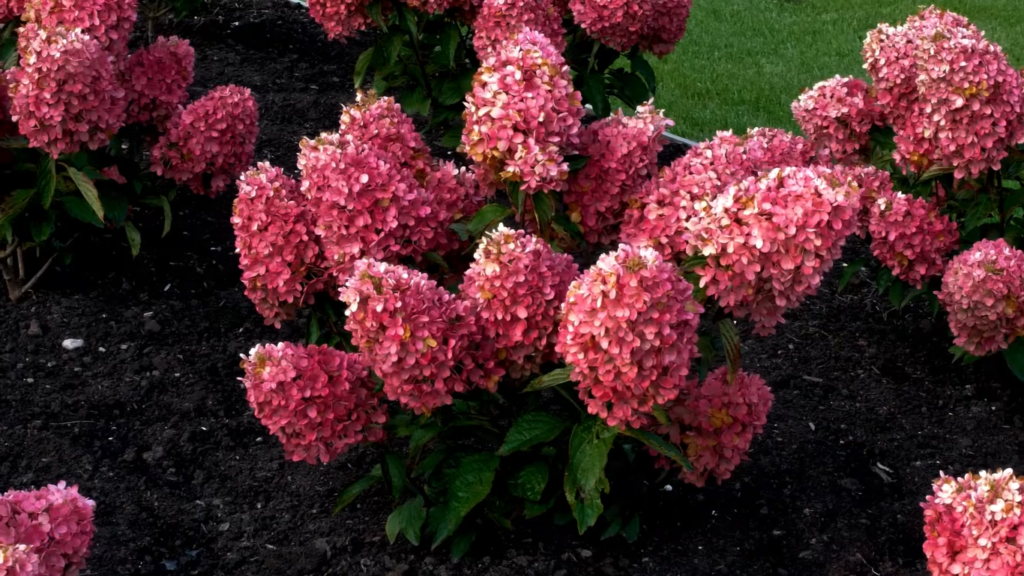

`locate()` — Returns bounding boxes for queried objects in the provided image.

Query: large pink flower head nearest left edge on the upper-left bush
[6,23,126,158]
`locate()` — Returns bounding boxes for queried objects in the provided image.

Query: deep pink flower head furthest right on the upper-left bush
[151,85,259,196]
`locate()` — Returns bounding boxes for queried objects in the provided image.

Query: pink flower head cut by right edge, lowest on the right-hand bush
[938,238,1024,356]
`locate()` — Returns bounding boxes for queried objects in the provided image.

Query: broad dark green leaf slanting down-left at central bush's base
[430,453,501,549]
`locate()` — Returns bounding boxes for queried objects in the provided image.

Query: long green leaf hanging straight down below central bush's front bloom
[564,417,617,534]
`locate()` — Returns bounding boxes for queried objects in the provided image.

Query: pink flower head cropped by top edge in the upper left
[23,0,138,57]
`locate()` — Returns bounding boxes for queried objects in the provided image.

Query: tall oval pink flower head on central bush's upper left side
[231,163,318,328]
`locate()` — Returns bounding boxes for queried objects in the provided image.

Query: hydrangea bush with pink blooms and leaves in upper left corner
[0,0,258,300]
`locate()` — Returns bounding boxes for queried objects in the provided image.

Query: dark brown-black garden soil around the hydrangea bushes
[0,0,1024,576]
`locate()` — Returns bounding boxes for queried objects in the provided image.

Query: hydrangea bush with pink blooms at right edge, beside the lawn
[793,7,1024,379]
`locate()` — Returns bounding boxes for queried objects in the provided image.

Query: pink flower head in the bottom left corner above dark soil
[0,482,96,576]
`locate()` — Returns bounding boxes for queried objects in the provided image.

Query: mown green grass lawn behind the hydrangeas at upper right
[654,0,1024,140]
